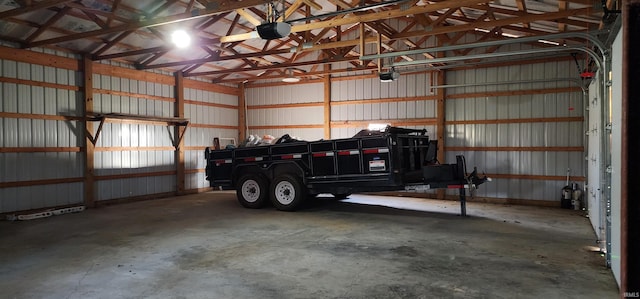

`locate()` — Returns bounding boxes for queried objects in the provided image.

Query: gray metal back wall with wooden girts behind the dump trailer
[247,60,586,202]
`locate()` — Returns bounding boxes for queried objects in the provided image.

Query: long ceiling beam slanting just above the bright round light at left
[27,0,268,48]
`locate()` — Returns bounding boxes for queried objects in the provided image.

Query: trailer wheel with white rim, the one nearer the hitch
[271,174,307,211]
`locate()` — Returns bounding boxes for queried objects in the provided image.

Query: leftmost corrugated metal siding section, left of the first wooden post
[0,60,84,213]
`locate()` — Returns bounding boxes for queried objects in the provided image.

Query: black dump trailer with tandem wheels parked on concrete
[205,127,488,215]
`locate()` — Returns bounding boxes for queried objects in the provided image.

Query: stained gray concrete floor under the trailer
[0,192,618,298]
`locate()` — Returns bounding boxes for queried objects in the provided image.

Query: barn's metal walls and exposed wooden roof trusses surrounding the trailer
[0,0,640,298]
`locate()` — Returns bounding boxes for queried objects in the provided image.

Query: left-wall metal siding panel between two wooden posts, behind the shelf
[93,70,176,201]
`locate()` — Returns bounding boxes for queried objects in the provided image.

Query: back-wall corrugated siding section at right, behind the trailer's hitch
[445,61,586,201]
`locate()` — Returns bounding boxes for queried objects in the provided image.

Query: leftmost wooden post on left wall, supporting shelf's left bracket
[82,55,96,208]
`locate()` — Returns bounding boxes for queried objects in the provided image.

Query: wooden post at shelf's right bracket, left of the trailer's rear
[173,71,187,195]
